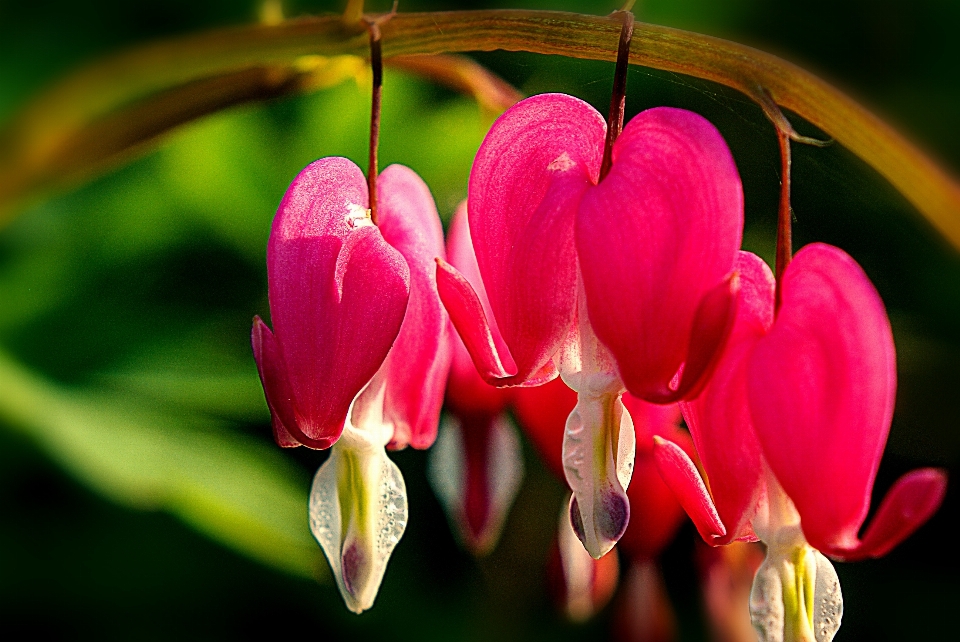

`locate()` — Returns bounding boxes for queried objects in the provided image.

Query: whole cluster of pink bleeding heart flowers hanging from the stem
[252,94,946,642]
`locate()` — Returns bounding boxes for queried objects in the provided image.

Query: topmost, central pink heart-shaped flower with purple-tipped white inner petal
[438,94,743,557]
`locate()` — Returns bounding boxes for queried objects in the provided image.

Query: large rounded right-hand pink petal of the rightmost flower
[748,243,896,550]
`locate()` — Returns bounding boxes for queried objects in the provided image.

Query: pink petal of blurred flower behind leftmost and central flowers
[447,202,509,417]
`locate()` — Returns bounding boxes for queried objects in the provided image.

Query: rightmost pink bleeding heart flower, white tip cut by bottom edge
[655,244,946,642]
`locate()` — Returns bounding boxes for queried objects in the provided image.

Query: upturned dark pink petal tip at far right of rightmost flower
[810,468,947,561]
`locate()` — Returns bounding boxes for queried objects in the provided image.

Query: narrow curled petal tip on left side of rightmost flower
[653,436,727,546]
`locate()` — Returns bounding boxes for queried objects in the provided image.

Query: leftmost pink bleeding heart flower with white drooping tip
[252,158,450,612]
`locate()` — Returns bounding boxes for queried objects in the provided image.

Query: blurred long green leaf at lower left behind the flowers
[0,352,326,577]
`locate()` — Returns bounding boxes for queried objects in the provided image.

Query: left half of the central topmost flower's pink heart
[468,94,606,385]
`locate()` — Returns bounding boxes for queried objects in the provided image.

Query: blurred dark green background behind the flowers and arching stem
[0,0,960,641]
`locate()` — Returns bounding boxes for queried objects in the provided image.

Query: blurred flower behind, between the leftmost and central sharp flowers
[429,204,523,555]
